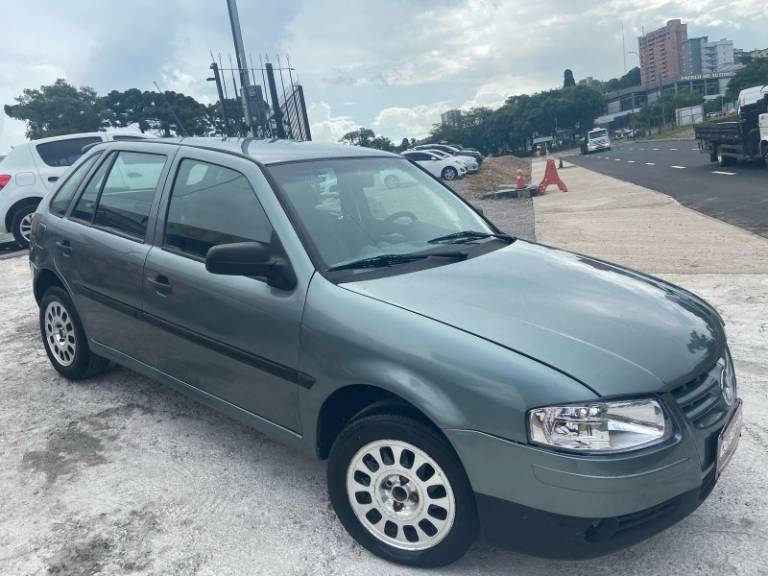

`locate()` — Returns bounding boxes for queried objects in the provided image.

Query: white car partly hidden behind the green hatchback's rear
[0,132,146,248]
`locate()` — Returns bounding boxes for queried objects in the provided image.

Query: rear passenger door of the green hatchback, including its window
[55,143,176,357]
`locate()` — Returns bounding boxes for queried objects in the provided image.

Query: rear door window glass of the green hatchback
[93,152,166,239]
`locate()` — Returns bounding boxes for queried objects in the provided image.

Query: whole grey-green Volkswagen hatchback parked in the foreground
[30,139,741,566]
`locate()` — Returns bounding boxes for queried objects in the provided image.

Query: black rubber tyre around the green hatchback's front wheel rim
[328,414,478,568]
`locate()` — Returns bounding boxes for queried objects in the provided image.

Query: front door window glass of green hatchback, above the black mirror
[165,160,272,258]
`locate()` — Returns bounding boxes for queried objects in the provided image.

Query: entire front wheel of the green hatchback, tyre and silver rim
[328,414,478,567]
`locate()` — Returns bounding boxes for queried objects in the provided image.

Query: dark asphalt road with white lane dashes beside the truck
[564,140,768,237]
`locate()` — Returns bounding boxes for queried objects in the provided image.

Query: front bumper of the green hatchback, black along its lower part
[445,398,733,558]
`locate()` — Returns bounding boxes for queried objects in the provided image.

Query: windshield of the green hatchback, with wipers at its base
[268,158,494,270]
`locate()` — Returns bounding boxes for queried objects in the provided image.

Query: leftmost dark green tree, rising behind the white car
[4,78,103,140]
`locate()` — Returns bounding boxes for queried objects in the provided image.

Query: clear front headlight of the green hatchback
[528,399,671,453]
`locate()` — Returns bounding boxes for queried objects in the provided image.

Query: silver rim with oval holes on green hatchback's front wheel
[347,440,456,550]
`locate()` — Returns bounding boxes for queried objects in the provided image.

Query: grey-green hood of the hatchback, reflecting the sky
[342,240,725,396]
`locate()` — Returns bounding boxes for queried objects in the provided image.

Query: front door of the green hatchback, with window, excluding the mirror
[141,149,304,431]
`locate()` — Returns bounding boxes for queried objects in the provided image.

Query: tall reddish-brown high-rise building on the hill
[637,18,688,86]
